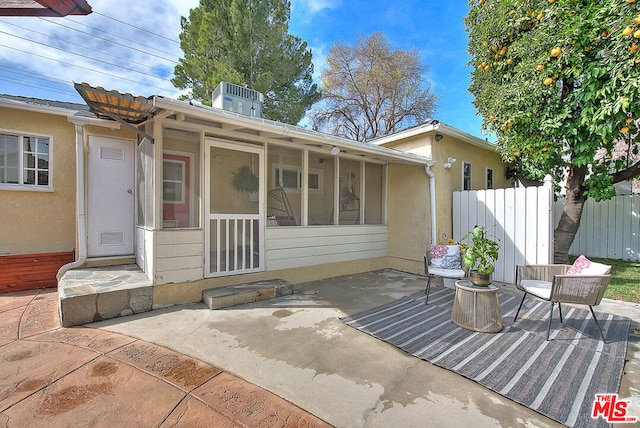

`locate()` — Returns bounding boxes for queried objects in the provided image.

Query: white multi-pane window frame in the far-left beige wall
[0,128,54,192]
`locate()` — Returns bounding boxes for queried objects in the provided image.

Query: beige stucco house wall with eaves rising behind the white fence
[386,132,511,247]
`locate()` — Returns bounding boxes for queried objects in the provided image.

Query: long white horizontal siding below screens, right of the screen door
[265,226,389,271]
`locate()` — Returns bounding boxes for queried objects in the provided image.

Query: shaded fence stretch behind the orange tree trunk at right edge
[554,195,640,261]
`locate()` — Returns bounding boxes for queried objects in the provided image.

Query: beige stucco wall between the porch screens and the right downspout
[387,164,431,273]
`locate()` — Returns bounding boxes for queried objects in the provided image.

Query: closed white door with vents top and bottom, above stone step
[87,136,134,257]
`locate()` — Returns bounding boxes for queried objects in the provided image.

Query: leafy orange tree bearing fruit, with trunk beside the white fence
[465,0,640,263]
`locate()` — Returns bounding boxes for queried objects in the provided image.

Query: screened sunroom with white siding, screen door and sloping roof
[70,84,430,305]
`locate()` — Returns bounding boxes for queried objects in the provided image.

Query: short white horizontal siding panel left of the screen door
[155,230,204,284]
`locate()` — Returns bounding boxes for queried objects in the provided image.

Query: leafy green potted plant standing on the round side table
[462,226,500,287]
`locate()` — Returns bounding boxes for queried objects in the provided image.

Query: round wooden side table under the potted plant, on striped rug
[451,279,502,333]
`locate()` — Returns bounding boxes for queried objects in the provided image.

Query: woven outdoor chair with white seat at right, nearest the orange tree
[513,256,611,343]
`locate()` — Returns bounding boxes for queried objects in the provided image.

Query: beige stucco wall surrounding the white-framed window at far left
[0,108,76,254]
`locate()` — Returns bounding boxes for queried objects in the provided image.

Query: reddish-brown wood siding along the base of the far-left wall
[0,251,74,293]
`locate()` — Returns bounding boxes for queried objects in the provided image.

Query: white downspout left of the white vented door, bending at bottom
[56,125,87,283]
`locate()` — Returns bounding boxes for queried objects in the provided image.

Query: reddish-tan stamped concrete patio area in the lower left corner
[0,289,328,428]
